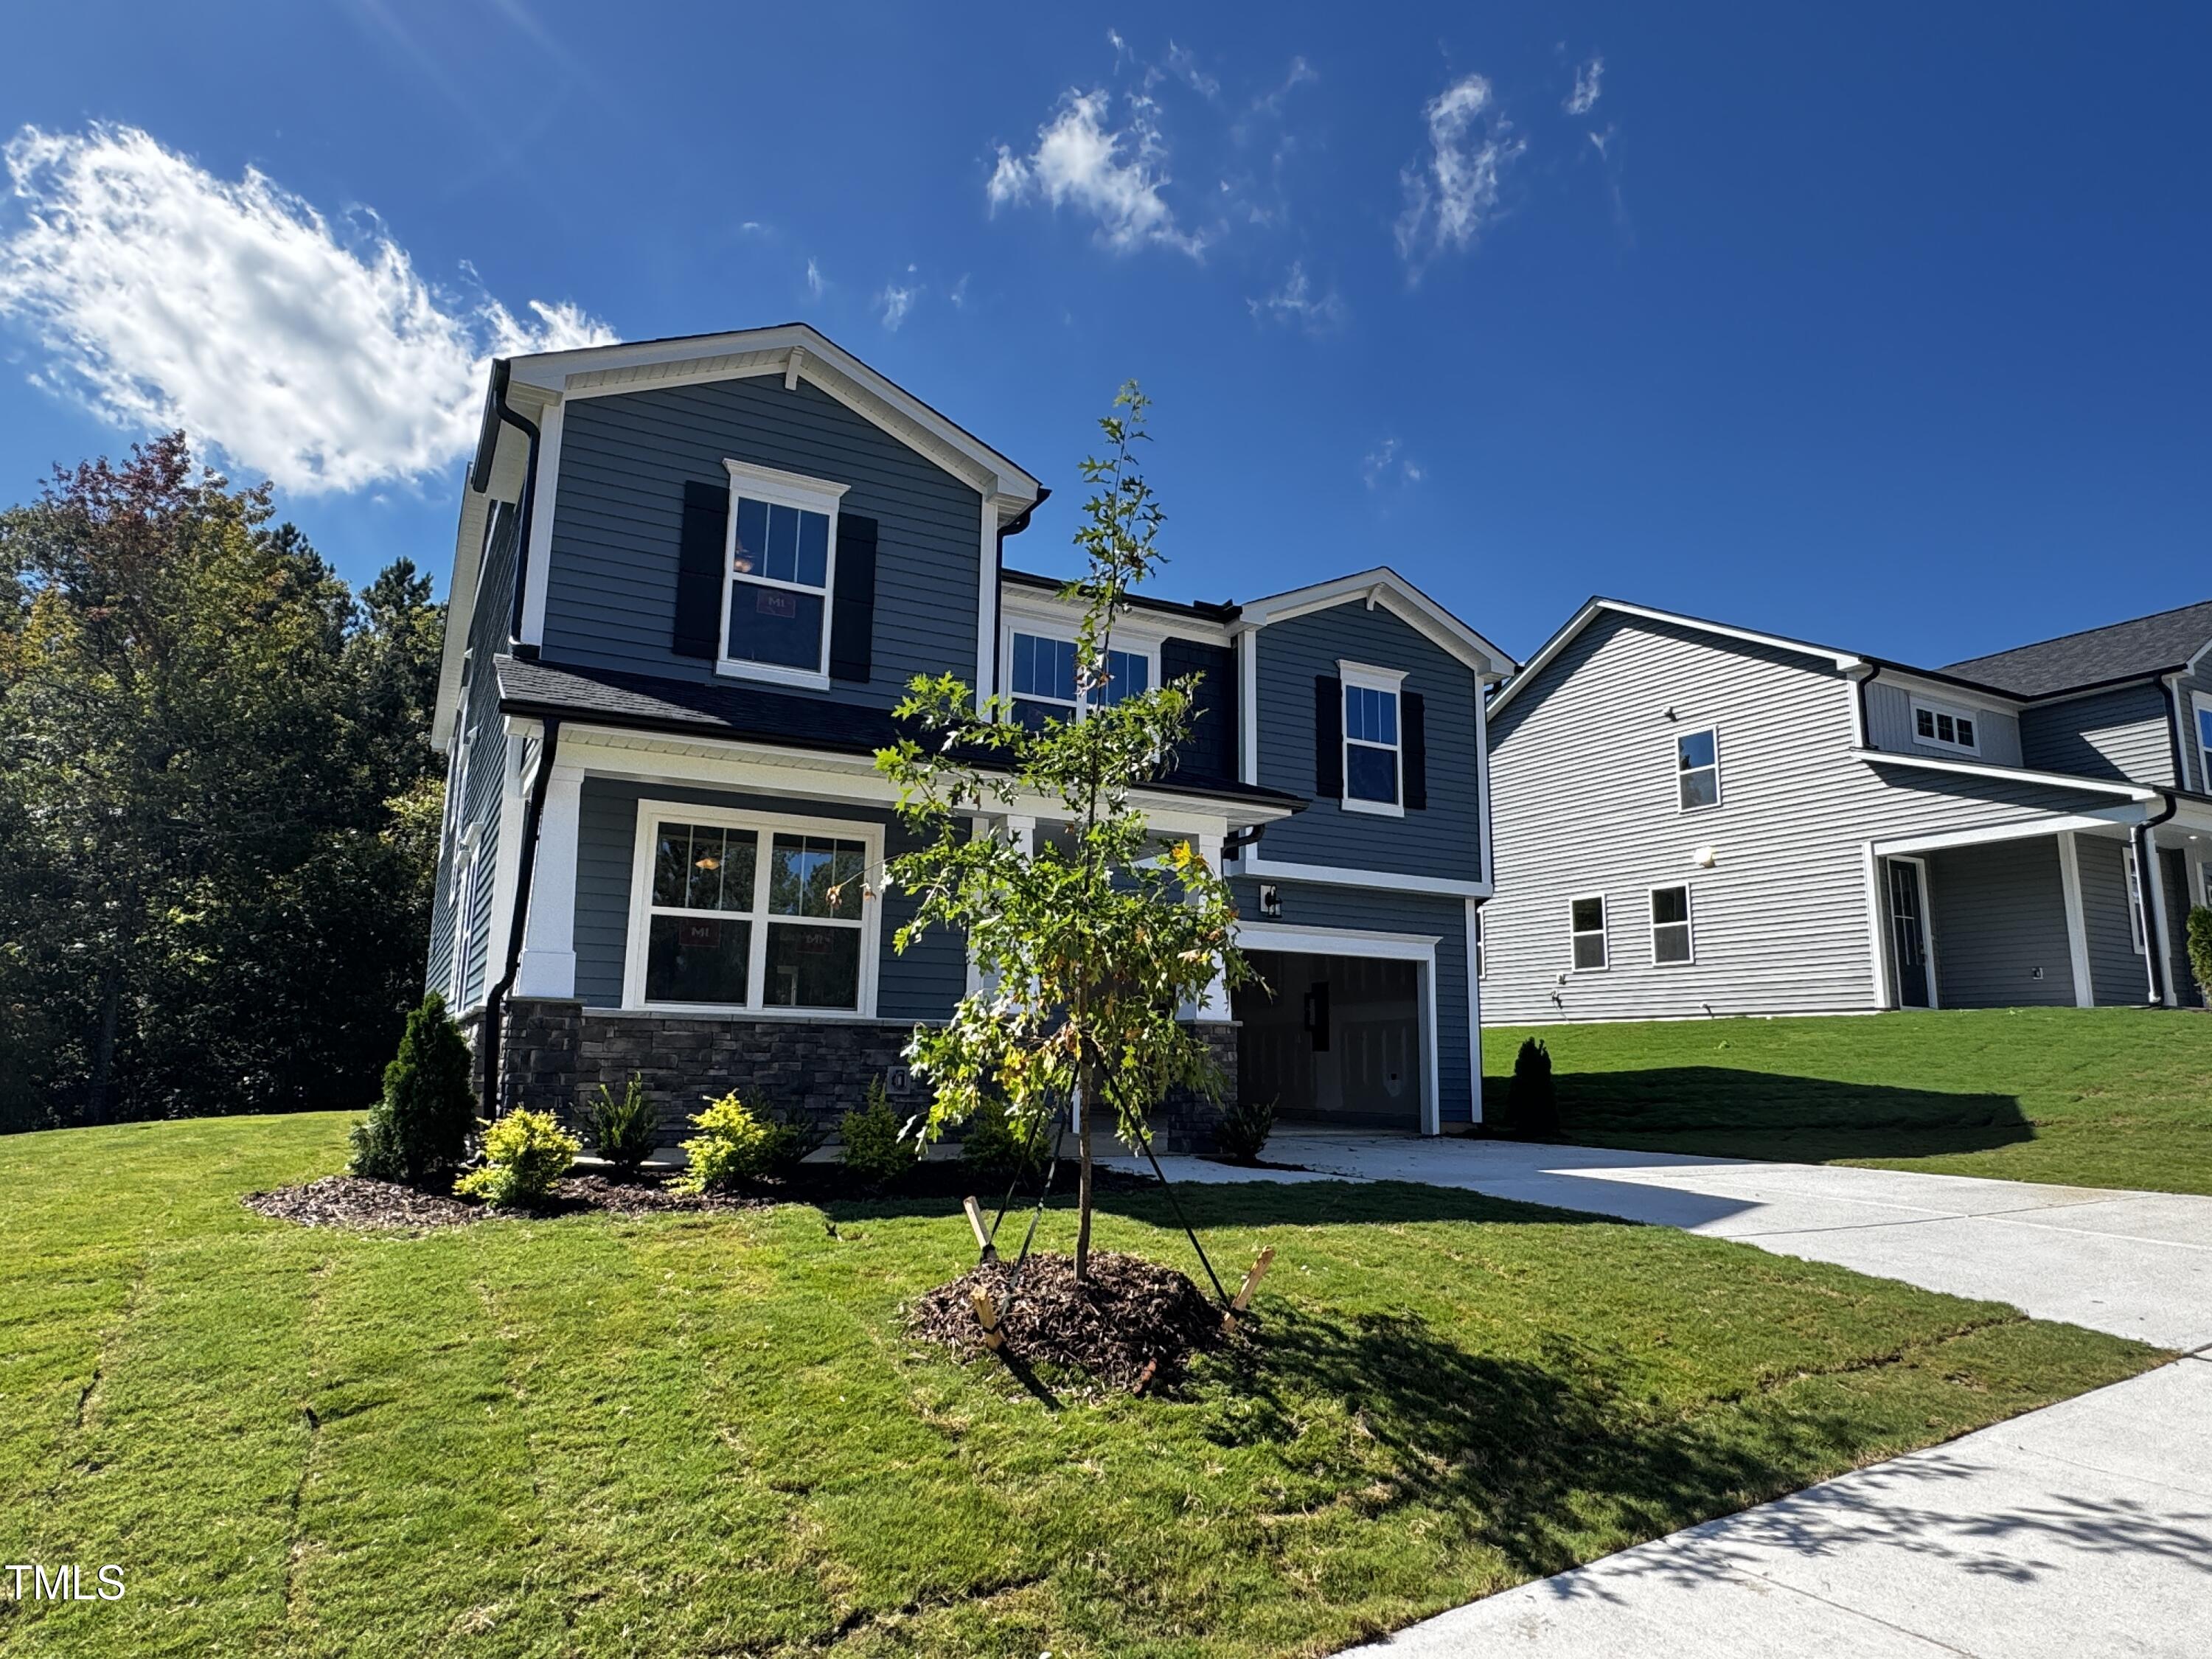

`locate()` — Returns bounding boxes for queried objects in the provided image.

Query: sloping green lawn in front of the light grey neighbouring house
[1482,1009,2212,1194]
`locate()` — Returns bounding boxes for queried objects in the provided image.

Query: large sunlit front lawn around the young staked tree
[0,1115,2161,1659]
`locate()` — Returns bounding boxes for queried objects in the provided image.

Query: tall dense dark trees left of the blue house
[0,434,445,1128]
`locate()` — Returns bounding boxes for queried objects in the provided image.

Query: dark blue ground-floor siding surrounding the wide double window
[575,779,967,1020]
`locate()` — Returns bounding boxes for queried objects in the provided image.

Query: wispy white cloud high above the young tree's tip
[984,91,1206,259]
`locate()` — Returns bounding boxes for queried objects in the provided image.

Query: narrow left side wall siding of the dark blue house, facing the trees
[425,502,518,1013]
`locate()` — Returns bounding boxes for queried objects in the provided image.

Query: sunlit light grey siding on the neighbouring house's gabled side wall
[1482,613,2126,1024]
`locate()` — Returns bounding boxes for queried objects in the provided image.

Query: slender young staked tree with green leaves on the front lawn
[876,380,1250,1279]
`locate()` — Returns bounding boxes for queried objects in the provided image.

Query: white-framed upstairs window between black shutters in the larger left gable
[721,460,845,686]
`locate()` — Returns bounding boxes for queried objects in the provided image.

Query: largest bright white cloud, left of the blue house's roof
[0,126,613,495]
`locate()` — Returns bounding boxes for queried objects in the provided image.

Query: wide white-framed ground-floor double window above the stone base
[626,805,883,1013]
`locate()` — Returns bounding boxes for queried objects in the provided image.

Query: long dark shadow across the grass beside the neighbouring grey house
[1484,1066,2035,1164]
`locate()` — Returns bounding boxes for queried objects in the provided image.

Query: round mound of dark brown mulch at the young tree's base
[907,1250,1228,1391]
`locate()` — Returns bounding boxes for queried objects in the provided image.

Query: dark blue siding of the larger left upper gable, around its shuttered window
[544,376,982,708]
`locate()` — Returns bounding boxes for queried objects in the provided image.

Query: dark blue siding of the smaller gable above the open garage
[1254,599,1482,880]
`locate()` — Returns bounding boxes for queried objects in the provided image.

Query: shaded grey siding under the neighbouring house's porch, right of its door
[1927,836,2075,1009]
